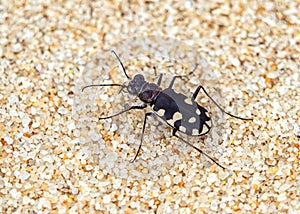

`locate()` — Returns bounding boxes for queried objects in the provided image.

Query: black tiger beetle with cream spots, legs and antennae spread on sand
[82,50,253,169]
